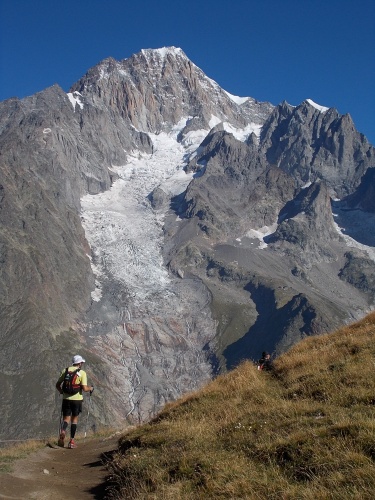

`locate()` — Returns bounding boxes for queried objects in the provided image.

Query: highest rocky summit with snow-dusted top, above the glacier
[71,46,276,133]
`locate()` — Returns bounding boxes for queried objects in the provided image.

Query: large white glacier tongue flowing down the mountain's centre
[81,133,197,304]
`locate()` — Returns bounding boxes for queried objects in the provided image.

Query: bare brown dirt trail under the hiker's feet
[0,434,120,500]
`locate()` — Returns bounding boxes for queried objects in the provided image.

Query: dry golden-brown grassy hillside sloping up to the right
[105,313,375,500]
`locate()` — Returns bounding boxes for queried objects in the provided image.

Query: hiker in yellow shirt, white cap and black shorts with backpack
[56,354,94,448]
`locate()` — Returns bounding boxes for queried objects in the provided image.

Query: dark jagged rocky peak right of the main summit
[262,100,374,198]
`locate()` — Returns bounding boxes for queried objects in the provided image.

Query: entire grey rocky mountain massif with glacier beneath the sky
[0,48,375,438]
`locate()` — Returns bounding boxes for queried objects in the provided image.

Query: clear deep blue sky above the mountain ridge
[0,0,375,145]
